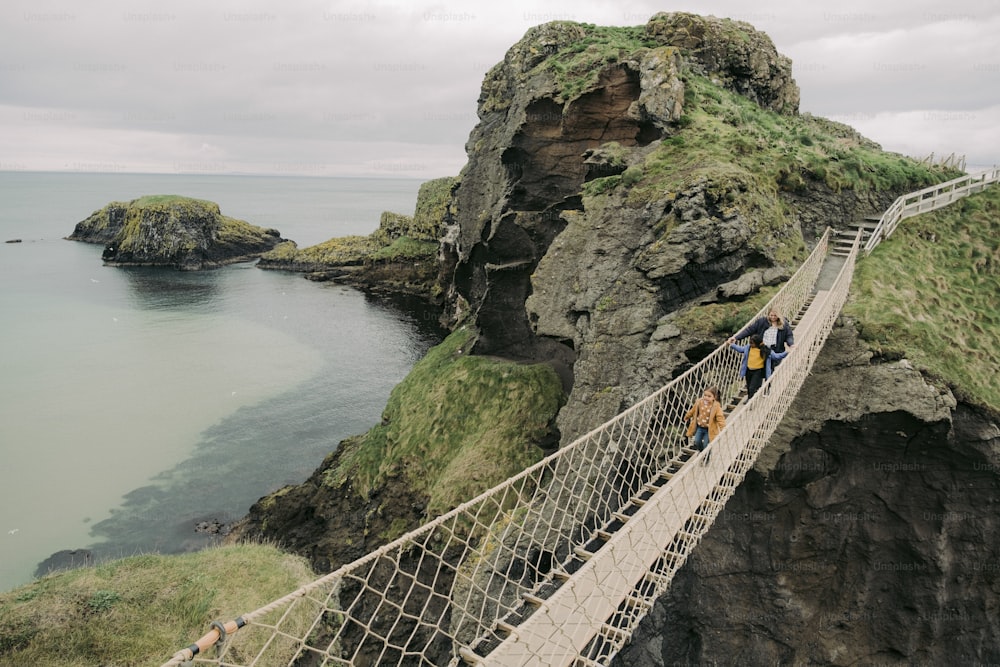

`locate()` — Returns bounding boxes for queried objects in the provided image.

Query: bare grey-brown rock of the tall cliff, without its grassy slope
[440,14,804,441]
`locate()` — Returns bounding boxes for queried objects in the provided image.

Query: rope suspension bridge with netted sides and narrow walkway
[164,230,844,667]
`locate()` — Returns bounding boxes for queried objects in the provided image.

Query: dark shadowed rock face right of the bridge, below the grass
[615,320,1000,666]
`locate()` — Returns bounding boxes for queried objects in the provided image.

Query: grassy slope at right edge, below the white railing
[844,185,1000,413]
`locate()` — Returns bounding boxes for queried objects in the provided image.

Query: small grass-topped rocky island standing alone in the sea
[66,195,285,271]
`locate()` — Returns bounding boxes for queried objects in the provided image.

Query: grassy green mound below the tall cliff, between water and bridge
[329,327,564,516]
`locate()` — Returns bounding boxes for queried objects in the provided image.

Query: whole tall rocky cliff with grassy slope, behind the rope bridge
[442,13,908,442]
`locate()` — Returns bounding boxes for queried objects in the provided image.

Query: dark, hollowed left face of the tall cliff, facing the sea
[442,23,683,357]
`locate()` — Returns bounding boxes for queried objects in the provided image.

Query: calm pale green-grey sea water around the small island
[0,172,441,590]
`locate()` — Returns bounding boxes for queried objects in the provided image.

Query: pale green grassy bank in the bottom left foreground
[0,545,316,667]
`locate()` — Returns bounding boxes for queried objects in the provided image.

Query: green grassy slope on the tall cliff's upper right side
[583,72,961,266]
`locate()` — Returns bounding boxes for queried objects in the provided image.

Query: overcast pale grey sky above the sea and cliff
[0,0,1000,179]
